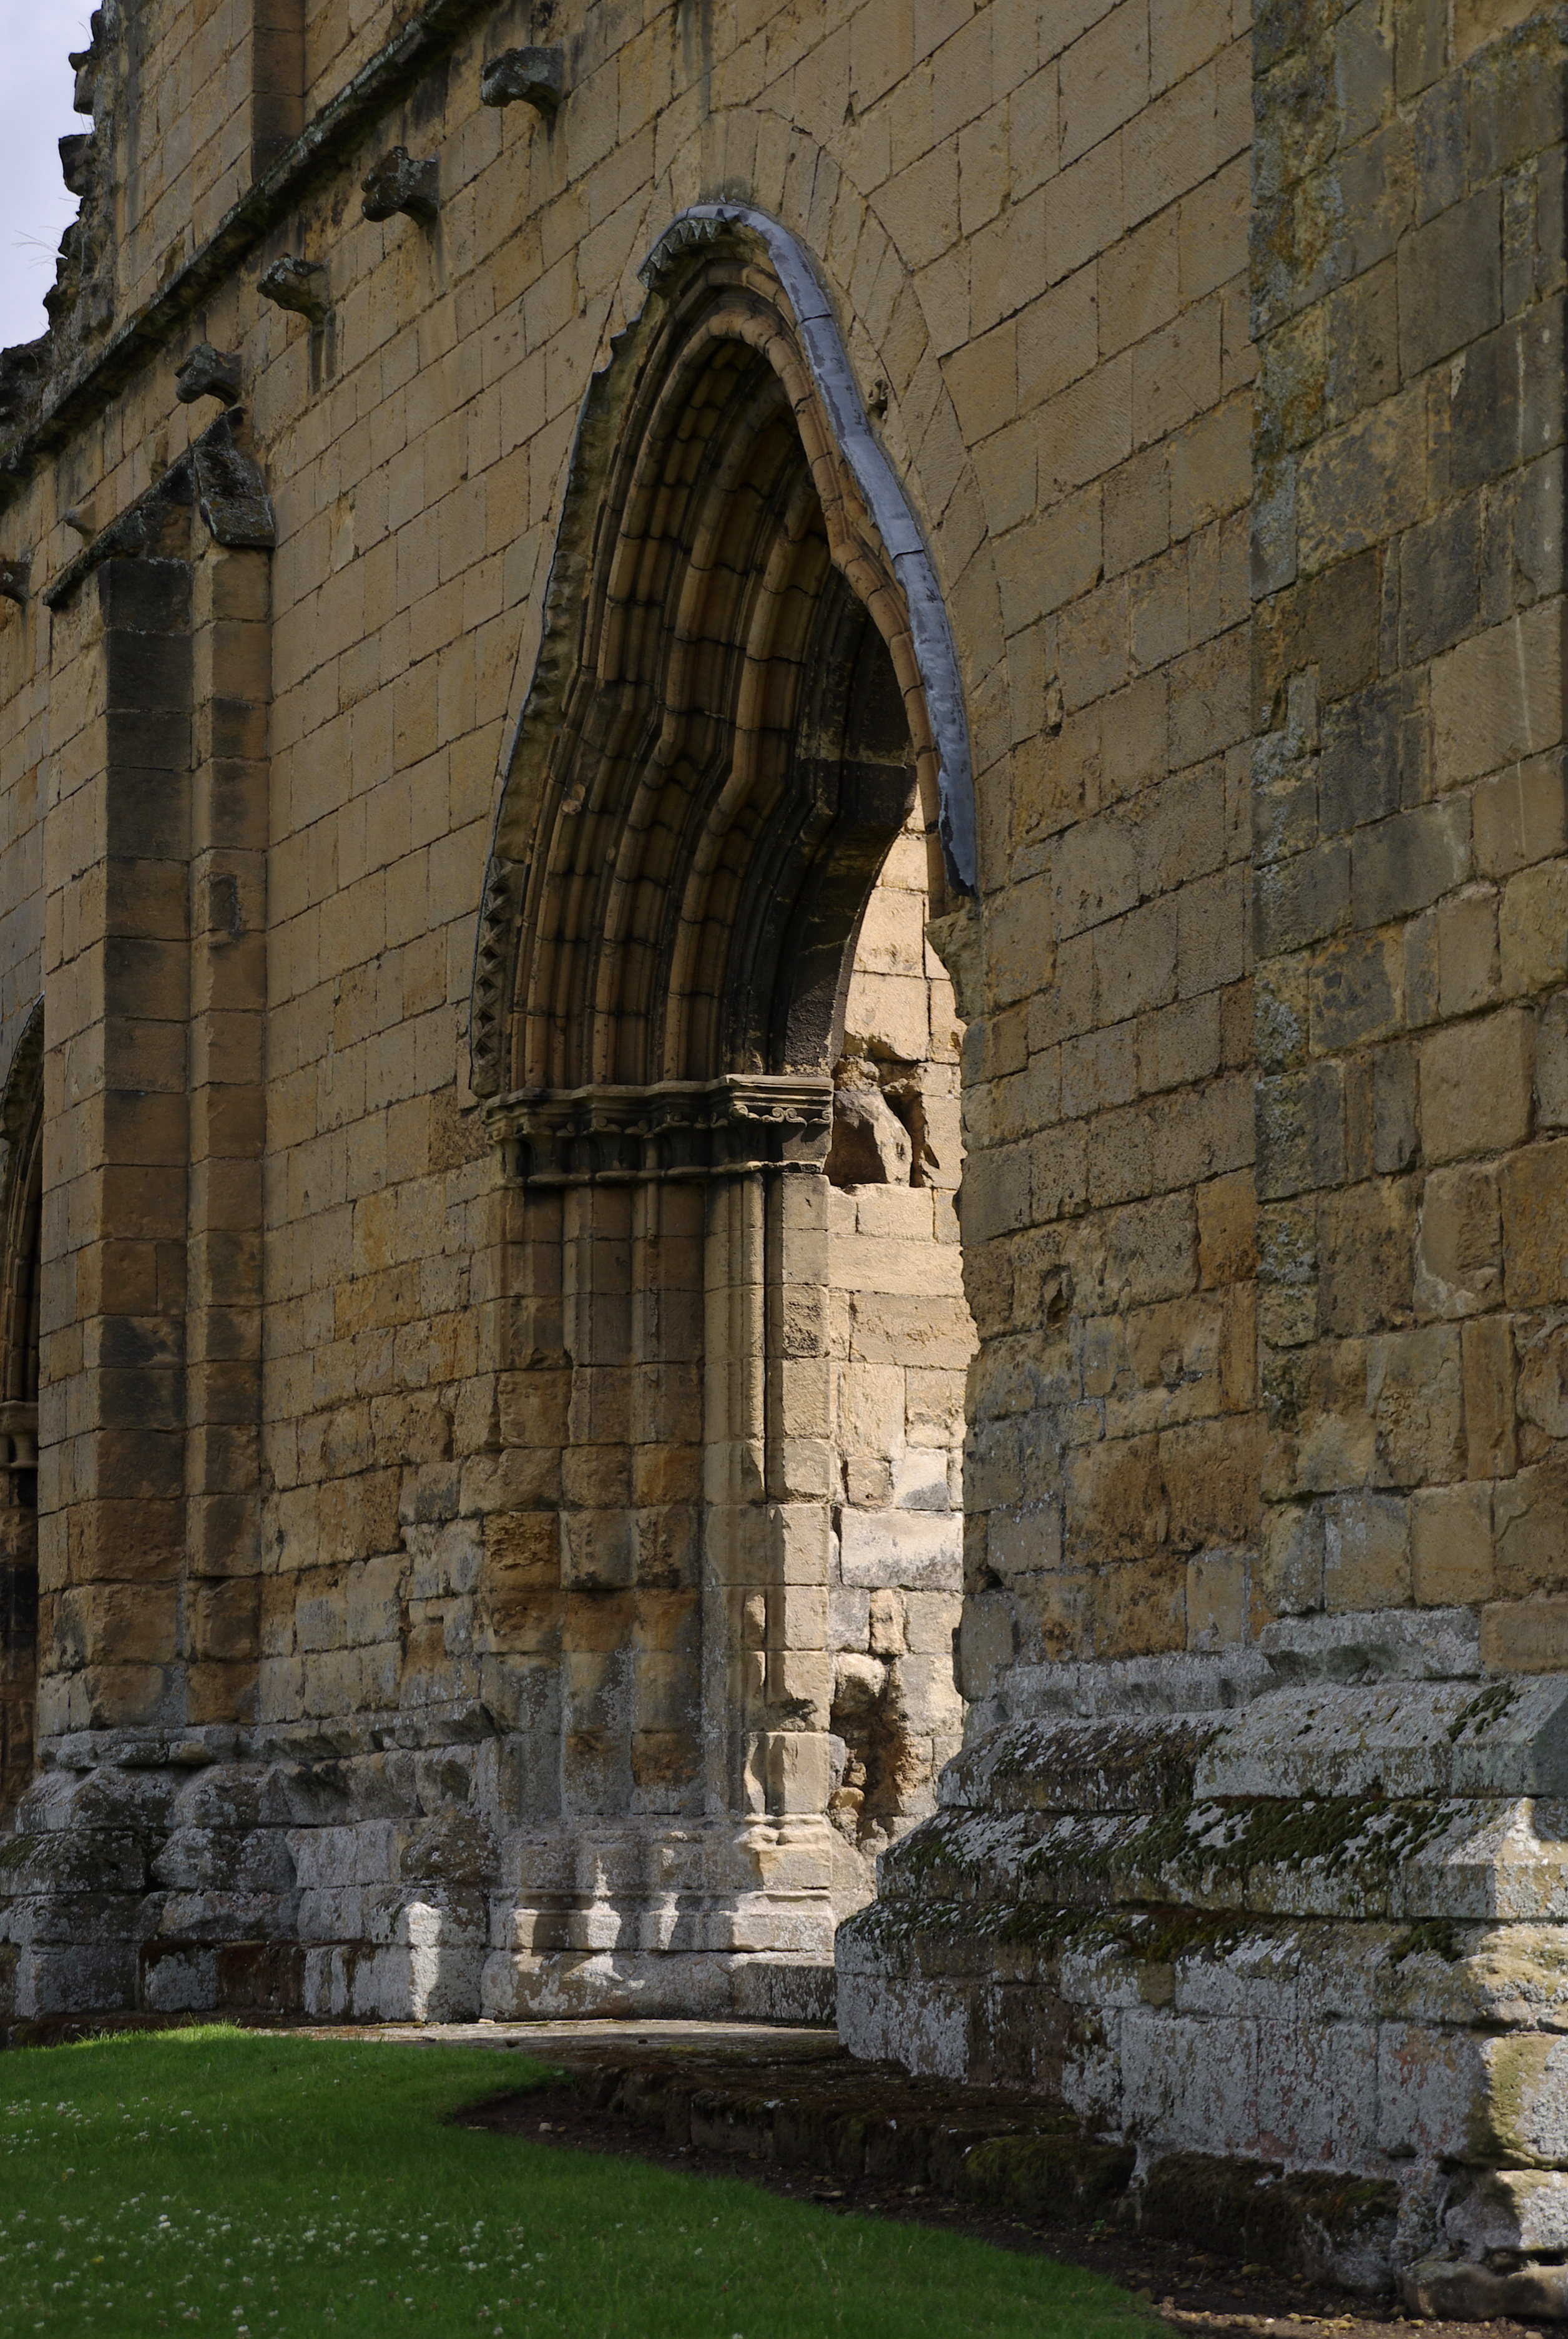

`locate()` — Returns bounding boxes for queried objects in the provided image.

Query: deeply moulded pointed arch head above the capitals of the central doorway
[471,203,976,1097]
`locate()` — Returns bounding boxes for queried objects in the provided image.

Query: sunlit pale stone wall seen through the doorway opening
[826,813,974,1916]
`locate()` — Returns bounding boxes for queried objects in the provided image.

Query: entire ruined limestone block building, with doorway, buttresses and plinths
[0,0,1568,2313]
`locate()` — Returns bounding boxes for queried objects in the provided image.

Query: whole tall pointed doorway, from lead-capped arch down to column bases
[473,206,974,2011]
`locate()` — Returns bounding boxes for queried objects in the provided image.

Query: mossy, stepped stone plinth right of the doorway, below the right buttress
[838,1679,1568,2313]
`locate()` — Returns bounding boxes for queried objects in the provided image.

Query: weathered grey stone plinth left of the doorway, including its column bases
[0,1733,833,2026]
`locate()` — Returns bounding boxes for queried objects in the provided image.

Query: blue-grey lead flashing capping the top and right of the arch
[637,203,978,893]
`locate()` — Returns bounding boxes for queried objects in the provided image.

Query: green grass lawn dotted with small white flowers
[0,2028,1152,2339]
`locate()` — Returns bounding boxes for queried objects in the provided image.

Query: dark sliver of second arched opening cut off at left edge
[0,999,44,1810]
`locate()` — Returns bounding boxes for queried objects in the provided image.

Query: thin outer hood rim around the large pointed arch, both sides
[468,203,978,1097]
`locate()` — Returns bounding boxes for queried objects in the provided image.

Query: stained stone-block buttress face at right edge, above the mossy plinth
[1255,0,1568,1672]
